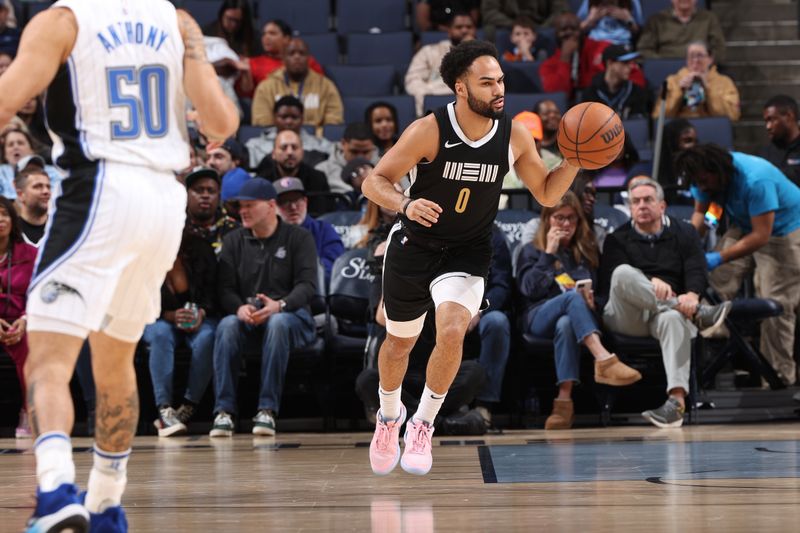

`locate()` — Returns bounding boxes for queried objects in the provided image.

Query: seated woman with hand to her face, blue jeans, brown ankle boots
[516,191,642,429]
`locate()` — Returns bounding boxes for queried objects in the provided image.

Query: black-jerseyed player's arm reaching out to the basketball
[511,122,580,206]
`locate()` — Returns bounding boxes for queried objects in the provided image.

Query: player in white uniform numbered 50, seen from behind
[0,0,238,532]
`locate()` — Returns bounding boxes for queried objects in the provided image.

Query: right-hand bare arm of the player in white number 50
[177,9,239,141]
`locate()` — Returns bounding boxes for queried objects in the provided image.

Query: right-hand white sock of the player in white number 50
[86,444,131,513]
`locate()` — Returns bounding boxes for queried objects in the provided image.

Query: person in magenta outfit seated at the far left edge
[0,197,36,437]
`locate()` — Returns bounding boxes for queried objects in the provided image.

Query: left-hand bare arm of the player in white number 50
[0,8,78,127]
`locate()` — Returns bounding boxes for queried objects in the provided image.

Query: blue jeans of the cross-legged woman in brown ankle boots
[528,291,599,385]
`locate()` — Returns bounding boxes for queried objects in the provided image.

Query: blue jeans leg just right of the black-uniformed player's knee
[475,311,511,402]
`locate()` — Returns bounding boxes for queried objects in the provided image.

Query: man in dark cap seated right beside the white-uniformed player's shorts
[184,167,239,255]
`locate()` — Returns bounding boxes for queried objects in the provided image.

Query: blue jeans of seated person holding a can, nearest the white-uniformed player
[144,318,217,407]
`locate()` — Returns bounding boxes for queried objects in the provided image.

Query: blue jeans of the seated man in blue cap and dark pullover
[214,309,317,413]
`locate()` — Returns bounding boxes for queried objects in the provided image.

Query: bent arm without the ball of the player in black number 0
[361,114,442,227]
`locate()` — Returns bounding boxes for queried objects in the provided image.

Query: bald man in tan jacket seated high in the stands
[253,37,344,128]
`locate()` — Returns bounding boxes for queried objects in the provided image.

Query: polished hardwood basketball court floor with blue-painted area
[0,424,800,533]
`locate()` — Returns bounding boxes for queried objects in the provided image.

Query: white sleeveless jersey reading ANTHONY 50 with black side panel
[45,0,189,171]
